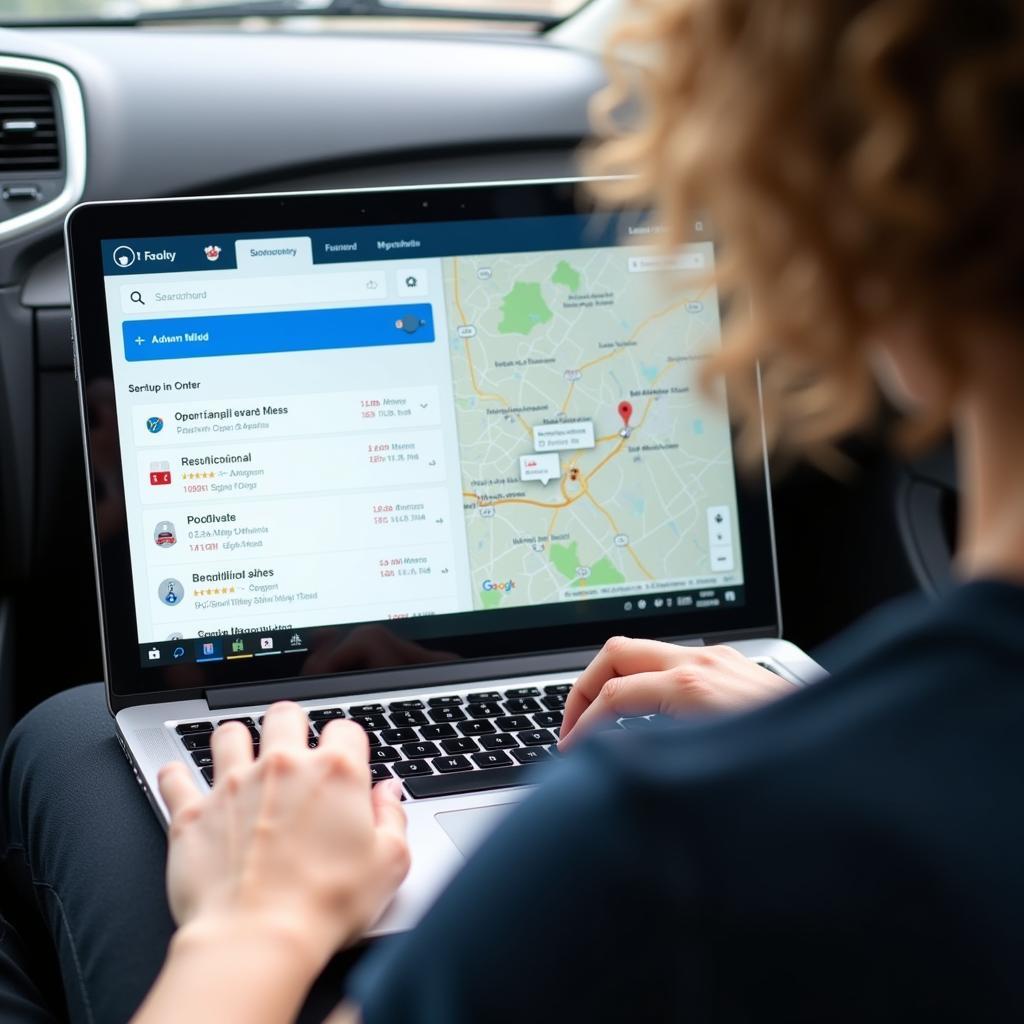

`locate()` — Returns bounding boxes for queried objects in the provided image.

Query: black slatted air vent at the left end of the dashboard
[0,75,60,174]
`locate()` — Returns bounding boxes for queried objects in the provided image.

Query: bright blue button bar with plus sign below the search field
[122,303,434,362]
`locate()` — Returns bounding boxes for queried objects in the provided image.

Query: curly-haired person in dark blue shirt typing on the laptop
[2,0,1024,1024]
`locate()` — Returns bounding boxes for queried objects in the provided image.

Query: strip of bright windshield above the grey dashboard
[0,0,585,27]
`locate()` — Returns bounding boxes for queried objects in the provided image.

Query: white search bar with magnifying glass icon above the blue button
[121,270,387,316]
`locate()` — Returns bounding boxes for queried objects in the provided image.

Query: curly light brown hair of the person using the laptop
[590,0,1024,464]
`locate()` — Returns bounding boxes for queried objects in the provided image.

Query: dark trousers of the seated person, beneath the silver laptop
[0,684,370,1024]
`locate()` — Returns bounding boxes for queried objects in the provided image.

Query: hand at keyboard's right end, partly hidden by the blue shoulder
[559,637,794,746]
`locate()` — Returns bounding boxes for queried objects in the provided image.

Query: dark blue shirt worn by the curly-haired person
[353,583,1024,1024]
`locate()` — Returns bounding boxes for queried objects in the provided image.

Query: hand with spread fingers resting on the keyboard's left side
[154,703,409,981]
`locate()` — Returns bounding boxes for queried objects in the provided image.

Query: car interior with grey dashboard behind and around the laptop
[0,0,957,999]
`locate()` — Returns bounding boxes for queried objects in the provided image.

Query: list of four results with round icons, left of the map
[140,387,460,636]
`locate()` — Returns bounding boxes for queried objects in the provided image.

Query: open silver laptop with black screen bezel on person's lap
[66,180,821,934]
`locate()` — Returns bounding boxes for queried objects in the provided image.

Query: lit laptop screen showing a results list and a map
[103,215,743,667]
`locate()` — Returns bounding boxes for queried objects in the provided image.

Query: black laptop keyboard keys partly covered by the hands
[174,683,585,798]
